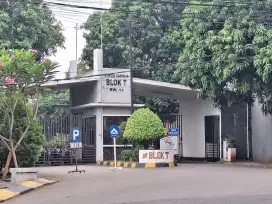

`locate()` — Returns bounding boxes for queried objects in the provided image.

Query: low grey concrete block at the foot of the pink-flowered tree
[10,168,39,185]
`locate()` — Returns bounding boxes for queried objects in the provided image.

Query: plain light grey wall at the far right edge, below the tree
[251,102,272,162]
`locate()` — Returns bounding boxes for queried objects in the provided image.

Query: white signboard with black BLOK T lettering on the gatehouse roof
[102,69,131,104]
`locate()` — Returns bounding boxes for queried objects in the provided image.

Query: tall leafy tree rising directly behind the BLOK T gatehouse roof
[82,0,184,113]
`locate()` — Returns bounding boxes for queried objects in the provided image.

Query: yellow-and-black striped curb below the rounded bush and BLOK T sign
[96,161,177,169]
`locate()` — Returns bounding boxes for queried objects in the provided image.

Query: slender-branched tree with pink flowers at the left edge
[0,50,58,168]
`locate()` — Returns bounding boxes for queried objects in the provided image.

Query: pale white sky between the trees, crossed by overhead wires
[46,0,111,78]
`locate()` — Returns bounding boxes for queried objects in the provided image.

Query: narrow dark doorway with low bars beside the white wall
[205,115,220,162]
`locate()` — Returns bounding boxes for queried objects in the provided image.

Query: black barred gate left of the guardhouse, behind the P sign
[36,115,96,166]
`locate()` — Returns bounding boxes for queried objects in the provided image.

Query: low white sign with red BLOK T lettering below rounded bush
[139,150,174,163]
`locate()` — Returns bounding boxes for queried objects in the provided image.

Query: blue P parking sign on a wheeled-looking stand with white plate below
[68,128,85,173]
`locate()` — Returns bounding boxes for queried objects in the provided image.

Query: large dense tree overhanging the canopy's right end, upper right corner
[172,0,272,113]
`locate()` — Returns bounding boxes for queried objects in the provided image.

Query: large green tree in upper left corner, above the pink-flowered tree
[0,0,64,55]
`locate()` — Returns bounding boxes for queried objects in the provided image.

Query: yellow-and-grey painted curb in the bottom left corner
[0,178,57,203]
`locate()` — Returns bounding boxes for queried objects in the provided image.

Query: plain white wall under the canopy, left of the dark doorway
[180,99,221,158]
